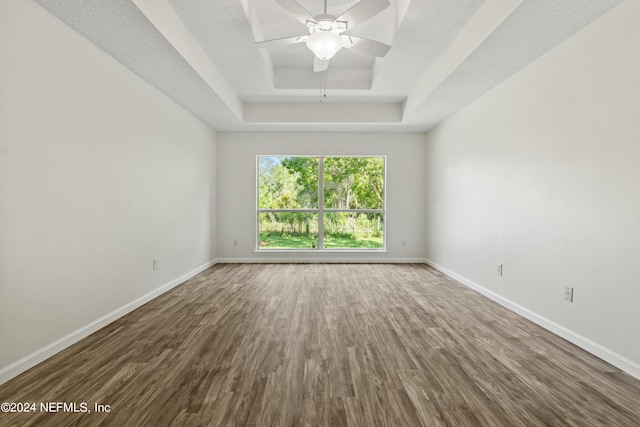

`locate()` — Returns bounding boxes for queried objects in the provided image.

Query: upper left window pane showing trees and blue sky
[258,156,318,209]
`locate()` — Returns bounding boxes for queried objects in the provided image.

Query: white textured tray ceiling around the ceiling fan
[36,0,621,131]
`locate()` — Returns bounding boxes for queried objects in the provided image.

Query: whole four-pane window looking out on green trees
[257,156,385,250]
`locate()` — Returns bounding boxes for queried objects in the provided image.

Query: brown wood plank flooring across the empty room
[0,264,640,427]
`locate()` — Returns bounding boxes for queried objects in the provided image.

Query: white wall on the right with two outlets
[426,0,640,377]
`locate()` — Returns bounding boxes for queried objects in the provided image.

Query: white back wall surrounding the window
[217,132,426,262]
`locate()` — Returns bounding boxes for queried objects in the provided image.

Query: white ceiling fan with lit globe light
[256,0,391,72]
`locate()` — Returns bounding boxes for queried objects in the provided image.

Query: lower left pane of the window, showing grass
[259,212,318,249]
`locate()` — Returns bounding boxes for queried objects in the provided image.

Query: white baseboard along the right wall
[425,260,640,379]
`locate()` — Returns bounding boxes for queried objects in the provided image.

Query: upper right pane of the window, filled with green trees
[324,157,384,211]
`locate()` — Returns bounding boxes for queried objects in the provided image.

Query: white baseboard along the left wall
[0,260,216,384]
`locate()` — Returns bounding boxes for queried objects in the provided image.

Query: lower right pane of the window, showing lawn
[324,212,384,249]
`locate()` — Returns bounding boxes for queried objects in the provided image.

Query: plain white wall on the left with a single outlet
[0,0,216,382]
